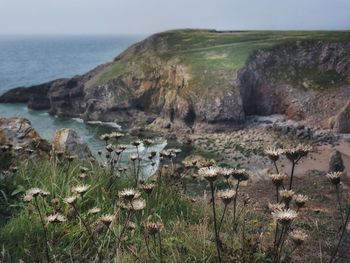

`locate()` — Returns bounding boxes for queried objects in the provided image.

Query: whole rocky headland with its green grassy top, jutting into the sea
[0,31,350,132]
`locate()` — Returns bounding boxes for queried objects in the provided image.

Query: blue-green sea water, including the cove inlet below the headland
[0,35,165,175]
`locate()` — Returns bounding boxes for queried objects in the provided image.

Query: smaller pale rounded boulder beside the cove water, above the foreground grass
[52,128,93,161]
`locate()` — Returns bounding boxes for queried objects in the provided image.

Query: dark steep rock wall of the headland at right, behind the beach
[239,41,350,123]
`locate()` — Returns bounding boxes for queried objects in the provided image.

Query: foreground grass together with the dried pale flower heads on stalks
[0,137,350,262]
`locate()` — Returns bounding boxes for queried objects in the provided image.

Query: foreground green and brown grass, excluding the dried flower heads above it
[0,144,350,262]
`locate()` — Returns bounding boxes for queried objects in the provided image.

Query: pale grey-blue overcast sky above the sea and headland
[0,0,350,34]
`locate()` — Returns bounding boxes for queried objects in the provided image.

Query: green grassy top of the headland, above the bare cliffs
[95,29,350,91]
